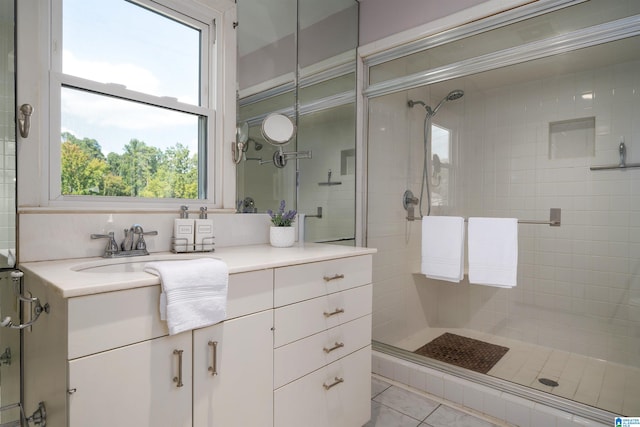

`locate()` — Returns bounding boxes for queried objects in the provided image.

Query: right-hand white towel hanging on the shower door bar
[468,218,518,288]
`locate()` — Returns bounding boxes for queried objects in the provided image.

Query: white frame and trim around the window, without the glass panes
[18,0,236,211]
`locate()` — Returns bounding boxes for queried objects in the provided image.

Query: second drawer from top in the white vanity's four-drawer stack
[274,285,372,348]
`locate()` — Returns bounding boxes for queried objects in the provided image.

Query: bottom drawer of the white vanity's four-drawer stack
[274,346,371,427]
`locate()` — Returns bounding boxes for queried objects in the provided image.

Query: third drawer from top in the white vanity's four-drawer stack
[274,314,371,388]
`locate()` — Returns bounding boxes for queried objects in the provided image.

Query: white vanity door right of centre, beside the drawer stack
[193,310,273,427]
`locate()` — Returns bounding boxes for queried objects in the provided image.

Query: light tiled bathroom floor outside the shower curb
[364,377,502,427]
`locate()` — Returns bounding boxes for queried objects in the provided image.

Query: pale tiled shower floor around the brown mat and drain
[396,328,640,416]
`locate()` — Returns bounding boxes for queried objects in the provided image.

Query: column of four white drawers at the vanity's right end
[274,255,372,427]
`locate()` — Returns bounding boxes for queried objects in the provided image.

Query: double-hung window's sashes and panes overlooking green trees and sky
[50,0,216,202]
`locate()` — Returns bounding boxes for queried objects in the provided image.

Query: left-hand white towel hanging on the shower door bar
[421,216,464,282]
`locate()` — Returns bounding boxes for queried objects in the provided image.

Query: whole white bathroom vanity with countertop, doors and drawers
[22,244,374,427]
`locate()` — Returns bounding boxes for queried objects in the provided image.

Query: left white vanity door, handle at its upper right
[68,333,192,427]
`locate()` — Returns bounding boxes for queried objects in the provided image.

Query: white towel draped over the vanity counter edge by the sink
[144,258,229,335]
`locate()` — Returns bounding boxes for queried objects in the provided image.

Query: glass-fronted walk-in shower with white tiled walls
[364,0,640,416]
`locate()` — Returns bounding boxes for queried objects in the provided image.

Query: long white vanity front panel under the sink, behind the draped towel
[68,270,273,359]
